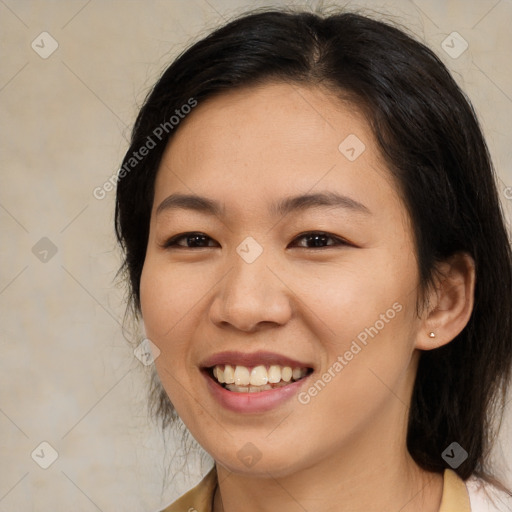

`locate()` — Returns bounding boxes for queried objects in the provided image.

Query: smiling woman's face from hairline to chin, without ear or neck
[141,84,425,475]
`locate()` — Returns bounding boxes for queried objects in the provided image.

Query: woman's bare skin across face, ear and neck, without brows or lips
[141,83,474,512]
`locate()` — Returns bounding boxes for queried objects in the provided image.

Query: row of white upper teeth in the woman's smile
[213,364,308,386]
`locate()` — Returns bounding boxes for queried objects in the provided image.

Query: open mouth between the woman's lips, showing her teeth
[206,364,313,393]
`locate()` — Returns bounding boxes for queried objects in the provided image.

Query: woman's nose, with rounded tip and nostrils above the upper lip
[210,247,292,332]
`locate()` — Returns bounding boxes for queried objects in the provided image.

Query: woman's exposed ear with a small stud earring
[415,252,475,350]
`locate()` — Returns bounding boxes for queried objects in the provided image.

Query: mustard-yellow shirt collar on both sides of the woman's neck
[161,466,471,512]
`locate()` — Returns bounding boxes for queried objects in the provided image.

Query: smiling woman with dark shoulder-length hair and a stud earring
[116,6,512,512]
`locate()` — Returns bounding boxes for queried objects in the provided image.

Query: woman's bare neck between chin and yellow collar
[213,450,443,512]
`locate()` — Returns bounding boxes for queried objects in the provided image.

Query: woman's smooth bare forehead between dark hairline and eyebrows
[154,83,398,219]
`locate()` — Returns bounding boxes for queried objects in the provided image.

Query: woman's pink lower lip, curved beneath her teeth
[201,371,309,413]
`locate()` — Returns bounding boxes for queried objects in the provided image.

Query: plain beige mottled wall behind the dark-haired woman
[0,0,512,512]
